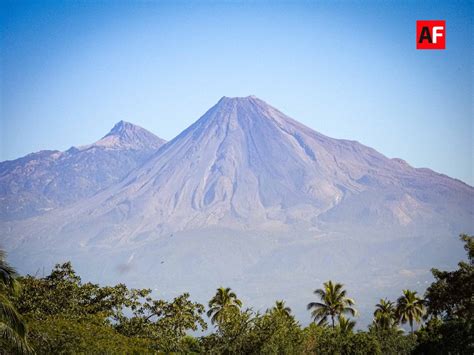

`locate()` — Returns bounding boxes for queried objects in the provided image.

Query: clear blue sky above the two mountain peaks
[0,1,474,185]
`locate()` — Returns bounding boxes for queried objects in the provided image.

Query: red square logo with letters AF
[416,20,446,49]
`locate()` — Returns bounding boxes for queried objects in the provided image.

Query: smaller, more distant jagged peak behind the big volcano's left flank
[0,121,164,220]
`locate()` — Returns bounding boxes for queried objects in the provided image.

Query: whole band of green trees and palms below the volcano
[0,235,474,354]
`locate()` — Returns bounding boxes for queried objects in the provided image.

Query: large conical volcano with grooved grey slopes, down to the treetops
[0,96,474,322]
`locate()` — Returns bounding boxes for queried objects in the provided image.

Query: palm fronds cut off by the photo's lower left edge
[0,250,31,353]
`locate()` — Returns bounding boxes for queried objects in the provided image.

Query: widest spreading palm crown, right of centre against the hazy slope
[307,281,357,328]
